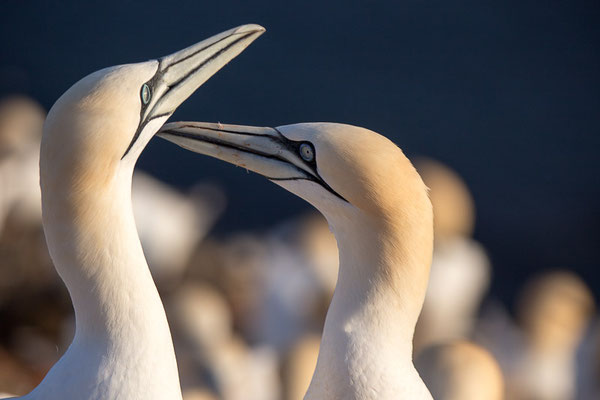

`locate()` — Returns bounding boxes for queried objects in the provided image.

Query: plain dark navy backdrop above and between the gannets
[0,0,600,302]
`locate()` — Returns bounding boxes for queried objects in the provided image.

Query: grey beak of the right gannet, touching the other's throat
[157,122,345,200]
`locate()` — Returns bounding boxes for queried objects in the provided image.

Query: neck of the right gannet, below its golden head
[305,211,431,400]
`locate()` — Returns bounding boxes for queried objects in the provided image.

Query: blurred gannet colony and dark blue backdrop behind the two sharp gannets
[0,0,600,400]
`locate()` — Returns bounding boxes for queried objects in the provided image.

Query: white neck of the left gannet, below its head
[23,165,181,400]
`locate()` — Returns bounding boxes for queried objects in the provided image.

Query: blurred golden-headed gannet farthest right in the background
[508,270,595,400]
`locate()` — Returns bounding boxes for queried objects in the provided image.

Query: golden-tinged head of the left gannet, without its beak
[40,61,162,194]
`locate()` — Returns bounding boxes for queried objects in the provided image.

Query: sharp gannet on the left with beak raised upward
[1,25,264,400]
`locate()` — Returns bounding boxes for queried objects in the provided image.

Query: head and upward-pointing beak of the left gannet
[40,25,264,195]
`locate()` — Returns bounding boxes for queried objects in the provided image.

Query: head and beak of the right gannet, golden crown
[158,122,431,230]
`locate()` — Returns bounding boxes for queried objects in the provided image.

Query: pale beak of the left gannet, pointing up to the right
[123,24,265,157]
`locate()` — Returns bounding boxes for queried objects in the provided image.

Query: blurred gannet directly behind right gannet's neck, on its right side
[414,159,491,352]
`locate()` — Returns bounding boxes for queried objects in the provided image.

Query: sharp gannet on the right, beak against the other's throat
[159,122,433,400]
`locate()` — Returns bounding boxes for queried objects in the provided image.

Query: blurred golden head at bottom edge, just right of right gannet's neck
[415,340,504,400]
